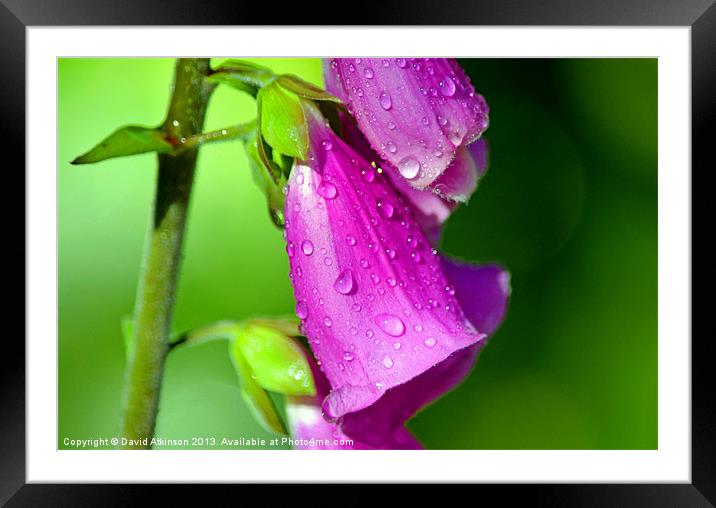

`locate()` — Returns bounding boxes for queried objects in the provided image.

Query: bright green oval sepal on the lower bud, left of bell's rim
[235,322,316,395]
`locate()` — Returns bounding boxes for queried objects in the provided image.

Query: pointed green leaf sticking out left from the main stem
[72,125,174,164]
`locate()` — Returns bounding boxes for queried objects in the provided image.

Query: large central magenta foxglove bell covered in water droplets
[285,104,484,418]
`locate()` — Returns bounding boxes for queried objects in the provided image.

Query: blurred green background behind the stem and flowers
[57,59,658,449]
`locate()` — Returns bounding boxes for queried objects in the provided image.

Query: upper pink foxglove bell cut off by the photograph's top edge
[324,58,489,189]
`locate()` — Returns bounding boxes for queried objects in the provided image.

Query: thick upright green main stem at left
[120,58,214,449]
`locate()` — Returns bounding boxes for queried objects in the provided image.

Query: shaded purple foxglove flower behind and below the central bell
[286,257,510,450]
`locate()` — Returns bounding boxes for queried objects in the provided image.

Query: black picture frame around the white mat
[0,0,716,507]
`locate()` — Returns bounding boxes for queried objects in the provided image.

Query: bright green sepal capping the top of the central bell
[258,81,308,159]
